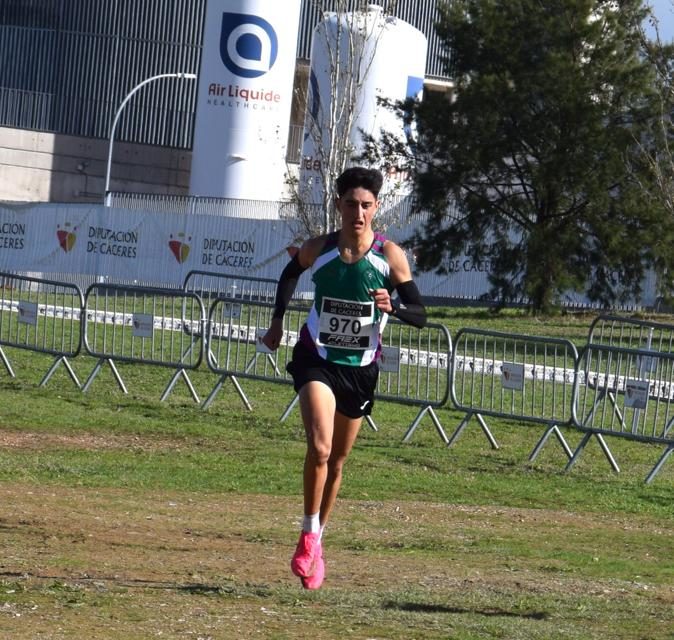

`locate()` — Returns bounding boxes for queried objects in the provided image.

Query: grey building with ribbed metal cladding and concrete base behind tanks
[0,0,451,203]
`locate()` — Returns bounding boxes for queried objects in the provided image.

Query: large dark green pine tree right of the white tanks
[372,0,671,312]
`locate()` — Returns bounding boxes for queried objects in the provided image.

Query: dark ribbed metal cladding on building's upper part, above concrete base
[0,0,447,149]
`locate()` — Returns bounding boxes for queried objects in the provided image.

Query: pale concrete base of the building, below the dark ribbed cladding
[0,127,192,202]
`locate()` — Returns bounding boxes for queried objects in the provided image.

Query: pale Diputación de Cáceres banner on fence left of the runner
[0,204,293,286]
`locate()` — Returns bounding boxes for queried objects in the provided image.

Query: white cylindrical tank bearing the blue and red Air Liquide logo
[190,0,301,200]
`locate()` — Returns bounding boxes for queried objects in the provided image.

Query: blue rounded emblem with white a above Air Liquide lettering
[220,12,278,78]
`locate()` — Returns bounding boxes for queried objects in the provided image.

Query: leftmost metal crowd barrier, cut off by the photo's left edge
[0,273,84,387]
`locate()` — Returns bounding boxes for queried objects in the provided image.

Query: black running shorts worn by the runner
[286,341,379,418]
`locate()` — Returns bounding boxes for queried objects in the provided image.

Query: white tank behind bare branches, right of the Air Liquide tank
[299,5,427,203]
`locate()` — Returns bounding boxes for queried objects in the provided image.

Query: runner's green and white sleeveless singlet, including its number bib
[301,232,393,367]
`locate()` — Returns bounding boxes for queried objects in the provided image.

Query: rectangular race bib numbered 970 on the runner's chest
[318,297,374,349]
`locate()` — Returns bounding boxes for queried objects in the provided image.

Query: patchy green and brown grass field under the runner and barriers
[0,309,674,640]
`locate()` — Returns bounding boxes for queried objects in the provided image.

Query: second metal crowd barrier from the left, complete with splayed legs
[82,284,205,402]
